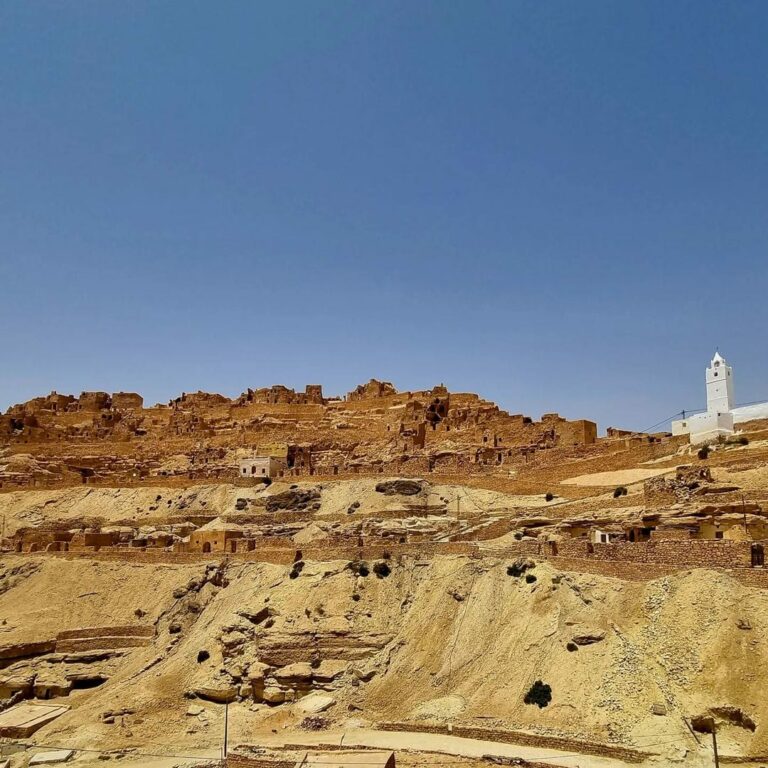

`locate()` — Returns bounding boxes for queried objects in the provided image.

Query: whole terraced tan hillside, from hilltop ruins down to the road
[0,356,768,768]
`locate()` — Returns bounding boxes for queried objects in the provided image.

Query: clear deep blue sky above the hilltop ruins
[0,0,768,428]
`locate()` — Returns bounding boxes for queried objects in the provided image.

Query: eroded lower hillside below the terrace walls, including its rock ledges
[0,557,768,755]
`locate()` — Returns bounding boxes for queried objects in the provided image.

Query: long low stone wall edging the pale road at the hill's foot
[378,723,651,763]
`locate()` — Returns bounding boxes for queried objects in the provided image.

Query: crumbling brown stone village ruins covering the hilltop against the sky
[0,379,597,488]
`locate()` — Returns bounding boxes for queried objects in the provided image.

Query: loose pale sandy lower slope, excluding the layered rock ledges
[0,557,768,757]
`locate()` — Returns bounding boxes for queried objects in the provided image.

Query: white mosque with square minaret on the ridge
[672,352,768,443]
